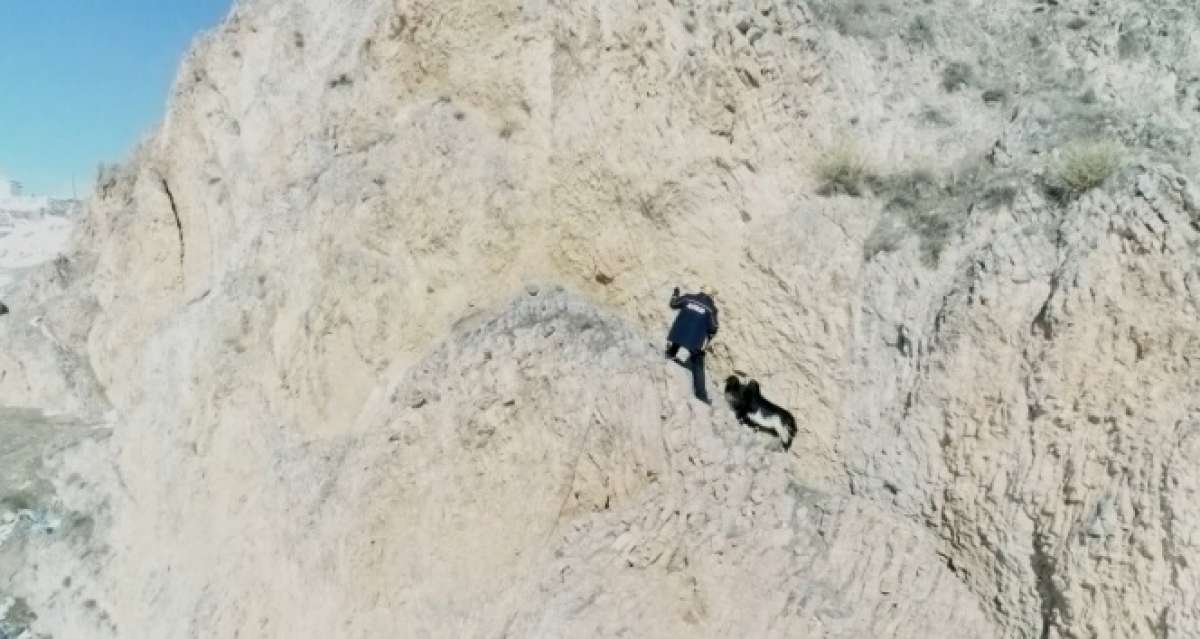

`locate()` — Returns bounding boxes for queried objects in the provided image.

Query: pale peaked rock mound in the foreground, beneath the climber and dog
[4,291,995,638]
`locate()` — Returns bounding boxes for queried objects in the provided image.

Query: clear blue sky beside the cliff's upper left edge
[0,0,233,196]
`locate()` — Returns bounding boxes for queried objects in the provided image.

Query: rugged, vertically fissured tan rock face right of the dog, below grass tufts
[847,169,1200,637]
